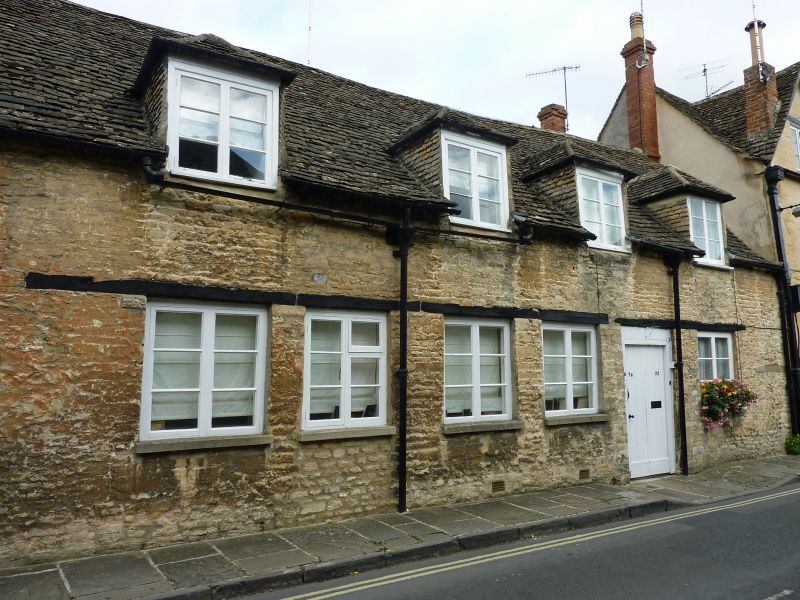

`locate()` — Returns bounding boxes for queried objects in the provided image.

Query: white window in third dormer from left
[577,169,627,250]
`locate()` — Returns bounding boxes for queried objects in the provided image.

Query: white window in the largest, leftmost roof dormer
[167,59,279,189]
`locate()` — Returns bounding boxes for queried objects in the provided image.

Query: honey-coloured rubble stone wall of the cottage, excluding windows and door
[0,147,788,565]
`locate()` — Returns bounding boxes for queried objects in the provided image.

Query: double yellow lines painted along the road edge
[285,488,800,600]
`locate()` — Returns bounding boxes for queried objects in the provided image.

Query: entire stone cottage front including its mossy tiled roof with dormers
[0,0,789,564]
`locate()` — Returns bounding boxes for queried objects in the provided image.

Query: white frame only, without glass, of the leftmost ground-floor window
[139,301,267,440]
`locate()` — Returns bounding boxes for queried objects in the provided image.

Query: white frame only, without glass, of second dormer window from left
[440,131,511,232]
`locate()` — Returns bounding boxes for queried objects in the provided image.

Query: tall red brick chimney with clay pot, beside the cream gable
[620,12,661,161]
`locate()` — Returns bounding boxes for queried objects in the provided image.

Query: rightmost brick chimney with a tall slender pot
[744,20,778,137]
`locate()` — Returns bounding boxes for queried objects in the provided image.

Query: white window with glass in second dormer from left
[442,132,509,231]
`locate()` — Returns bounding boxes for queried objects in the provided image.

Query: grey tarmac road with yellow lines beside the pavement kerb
[249,484,800,600]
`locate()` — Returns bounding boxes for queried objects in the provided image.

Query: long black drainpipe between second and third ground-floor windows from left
[387,206,414,512]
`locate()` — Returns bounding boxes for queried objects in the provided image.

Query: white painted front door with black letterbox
[625,344,673,477]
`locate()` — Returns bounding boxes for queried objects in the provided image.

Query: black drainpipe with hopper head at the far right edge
[764,166,800,433]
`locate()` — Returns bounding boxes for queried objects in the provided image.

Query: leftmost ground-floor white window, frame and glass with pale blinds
[140,302,267,440]
